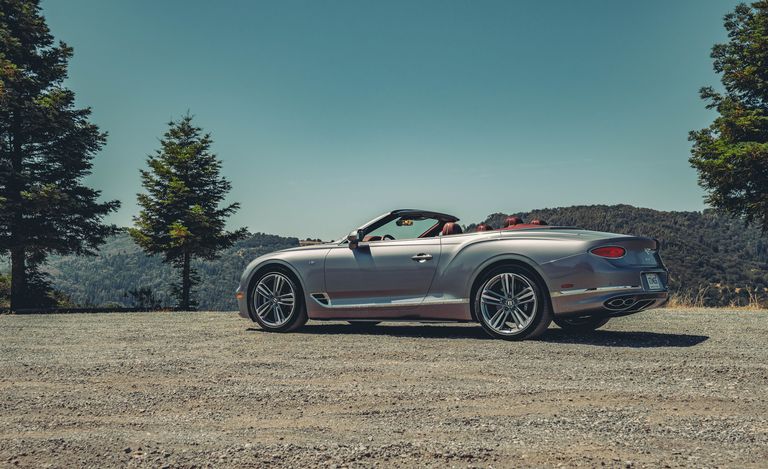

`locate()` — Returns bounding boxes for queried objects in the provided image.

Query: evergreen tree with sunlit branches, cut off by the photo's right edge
[690,0,768,232]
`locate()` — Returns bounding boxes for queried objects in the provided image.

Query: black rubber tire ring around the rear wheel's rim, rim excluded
[472,265,552,340]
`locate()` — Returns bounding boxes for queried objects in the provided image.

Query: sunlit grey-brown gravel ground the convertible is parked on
[0,310,768,467]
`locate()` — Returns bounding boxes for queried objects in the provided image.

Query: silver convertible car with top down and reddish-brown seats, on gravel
[236,209,668,340]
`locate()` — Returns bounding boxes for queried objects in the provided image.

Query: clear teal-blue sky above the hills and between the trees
[42,0,736,239]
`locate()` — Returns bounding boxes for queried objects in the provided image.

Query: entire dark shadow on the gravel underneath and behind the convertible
[247,323,709,348]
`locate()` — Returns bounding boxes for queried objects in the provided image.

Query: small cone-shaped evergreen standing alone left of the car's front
[130,114,247,310]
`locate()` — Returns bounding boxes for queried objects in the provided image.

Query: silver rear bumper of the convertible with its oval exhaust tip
[550,287,669,317]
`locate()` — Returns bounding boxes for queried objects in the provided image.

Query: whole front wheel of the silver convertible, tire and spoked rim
[248,267,307,332]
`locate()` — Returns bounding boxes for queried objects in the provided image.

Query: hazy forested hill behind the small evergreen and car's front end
[47,233,299,311]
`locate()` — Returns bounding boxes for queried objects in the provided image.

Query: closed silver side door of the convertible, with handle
[325,238,440,317]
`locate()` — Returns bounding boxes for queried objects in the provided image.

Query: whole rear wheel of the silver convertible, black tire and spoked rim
[473,265,552,340]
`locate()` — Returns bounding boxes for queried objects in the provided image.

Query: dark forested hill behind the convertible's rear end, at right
[468,205,768,306]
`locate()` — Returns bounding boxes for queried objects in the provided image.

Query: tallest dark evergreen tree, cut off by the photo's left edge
[0,0,119,309]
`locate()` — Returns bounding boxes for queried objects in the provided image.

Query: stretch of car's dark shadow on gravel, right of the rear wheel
[539,329,709,348]
